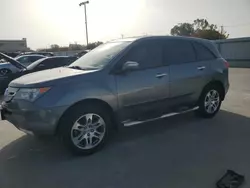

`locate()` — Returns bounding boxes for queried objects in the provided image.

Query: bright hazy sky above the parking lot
[0,0,250,49]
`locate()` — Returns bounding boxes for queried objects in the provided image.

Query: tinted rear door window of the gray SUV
[164,39,195,64]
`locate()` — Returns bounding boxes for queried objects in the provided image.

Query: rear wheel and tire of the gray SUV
[196,85,223,118]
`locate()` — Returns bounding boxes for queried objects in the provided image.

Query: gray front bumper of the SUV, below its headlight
[1,100,66,135]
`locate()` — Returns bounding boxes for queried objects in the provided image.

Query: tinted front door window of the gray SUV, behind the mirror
[123,41,162,69]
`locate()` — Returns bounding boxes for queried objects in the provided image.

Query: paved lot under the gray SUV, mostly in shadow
[0,68,250,188]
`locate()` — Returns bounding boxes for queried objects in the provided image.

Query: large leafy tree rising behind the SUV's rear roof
[170,19,229,40]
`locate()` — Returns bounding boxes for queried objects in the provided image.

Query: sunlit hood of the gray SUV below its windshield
[9,67,96,87]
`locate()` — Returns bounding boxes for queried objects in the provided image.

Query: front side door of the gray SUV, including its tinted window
[116,41,169,121]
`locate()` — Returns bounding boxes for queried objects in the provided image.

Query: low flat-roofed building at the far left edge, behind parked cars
[0,38,30,52]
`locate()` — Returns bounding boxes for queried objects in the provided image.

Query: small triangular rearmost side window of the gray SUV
[193,42,216,61]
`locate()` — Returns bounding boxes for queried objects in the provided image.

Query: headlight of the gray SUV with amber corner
[15,87,50,102]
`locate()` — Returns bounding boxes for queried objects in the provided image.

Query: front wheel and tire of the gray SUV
[59,104,112,155]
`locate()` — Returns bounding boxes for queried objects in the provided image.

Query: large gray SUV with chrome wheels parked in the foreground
[1,36,229,154]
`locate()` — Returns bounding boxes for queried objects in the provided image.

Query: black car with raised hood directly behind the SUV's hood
[0,56,77,93]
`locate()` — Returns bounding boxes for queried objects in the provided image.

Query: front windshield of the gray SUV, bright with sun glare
[69,41,130,69]
